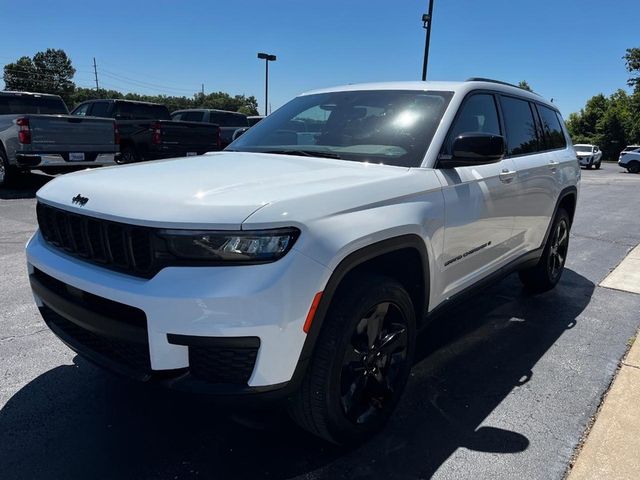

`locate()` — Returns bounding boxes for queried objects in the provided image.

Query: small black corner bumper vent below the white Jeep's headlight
[189,339,259,385]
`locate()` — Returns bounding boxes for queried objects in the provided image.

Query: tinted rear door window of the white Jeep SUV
[500,97,538,155]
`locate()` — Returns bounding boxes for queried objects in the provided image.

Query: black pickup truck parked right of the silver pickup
[71,100,222,163]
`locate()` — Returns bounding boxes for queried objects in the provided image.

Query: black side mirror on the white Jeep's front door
[438,133,505,168]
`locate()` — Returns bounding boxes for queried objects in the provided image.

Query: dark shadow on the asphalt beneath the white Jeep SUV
[0,270,595,480]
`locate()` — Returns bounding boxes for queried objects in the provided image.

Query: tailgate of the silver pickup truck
[29,115,116,151]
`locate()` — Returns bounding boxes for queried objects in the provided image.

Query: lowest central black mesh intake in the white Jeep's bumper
[40,306,151,374]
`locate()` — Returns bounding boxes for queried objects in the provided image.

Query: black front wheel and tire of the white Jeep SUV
[289,274,416,445]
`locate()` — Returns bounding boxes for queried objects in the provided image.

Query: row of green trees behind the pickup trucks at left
[3,48,258,115]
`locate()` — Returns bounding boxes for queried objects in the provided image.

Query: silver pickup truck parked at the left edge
[0,92,119,186]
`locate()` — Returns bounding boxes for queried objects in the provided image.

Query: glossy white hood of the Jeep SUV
[37,152,416,229]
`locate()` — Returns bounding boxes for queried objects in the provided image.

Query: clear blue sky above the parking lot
[0,0,640,116]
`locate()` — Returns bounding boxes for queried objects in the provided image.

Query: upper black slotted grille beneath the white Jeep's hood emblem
[36,203,157,278]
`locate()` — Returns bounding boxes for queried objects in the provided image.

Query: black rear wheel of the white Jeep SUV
[518,208,571,293]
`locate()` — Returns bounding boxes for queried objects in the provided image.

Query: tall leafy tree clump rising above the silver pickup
[3,48,76,101]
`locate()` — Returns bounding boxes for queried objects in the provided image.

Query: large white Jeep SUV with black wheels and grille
[27,80,580,443]
